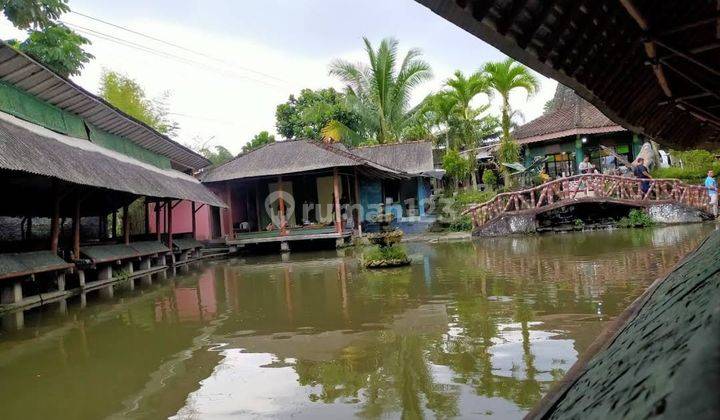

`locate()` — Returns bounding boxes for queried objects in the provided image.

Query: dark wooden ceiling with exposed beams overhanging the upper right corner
[417,0,720,149]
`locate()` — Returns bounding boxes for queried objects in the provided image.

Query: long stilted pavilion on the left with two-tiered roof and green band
[0,43,225,320]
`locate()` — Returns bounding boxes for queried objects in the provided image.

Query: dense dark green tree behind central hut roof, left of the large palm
[275,88,360,143]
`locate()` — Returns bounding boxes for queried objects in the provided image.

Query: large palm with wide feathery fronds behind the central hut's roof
[322,38,432,144]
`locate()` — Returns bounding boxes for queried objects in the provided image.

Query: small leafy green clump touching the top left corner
[0,0,70,29]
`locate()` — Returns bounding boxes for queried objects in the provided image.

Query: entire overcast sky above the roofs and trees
[0,0,556,153]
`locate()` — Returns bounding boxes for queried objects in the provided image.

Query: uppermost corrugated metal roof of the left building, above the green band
[0,41,210,170]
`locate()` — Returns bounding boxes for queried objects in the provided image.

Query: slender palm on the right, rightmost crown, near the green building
[483,58,540,183]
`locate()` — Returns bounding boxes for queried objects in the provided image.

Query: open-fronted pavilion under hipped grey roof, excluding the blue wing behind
[202,140,408,250]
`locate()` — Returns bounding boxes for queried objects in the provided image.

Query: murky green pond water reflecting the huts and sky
[0,225,714,419]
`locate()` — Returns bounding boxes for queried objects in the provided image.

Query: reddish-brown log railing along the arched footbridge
[463,174,709,227]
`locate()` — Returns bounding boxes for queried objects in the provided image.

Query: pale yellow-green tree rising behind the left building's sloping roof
[100,70,179,136]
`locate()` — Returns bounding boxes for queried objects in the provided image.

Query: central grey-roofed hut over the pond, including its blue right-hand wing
[201,140,433,249]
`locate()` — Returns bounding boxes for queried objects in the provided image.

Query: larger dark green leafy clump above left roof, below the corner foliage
[9,23,95,77]
